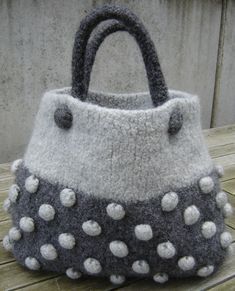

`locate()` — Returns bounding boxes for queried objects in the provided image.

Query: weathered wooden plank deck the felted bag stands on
[0,125,235,291]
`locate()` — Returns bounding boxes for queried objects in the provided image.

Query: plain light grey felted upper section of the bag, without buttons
[24,89,213,201]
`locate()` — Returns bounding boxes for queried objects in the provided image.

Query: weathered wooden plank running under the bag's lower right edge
[116,243,235,291]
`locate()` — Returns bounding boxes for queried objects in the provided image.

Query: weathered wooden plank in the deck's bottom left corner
[0,262,58,290]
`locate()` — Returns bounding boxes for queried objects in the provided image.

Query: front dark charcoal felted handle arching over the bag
[71,5,168,106]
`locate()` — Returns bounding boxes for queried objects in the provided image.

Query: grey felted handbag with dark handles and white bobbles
[3,6,232,284]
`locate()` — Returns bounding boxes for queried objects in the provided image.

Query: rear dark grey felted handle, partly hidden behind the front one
[84,19,128,95]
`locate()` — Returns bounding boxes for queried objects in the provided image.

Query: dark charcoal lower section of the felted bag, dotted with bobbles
[11,166,225,277]
